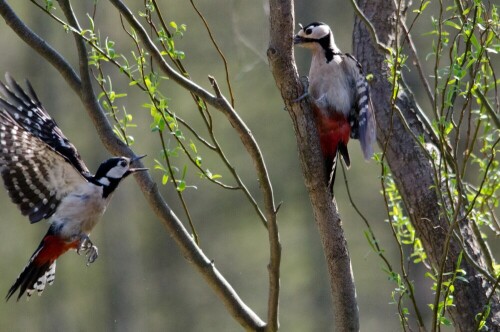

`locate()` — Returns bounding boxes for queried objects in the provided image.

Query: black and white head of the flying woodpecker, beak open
[94,155,147,197]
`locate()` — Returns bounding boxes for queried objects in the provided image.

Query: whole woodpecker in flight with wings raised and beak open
[0,74,147,300]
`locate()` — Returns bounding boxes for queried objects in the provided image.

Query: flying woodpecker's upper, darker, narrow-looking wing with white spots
[0,74,90,175]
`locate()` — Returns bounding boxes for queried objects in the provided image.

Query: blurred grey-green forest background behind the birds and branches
[0,0,499,331]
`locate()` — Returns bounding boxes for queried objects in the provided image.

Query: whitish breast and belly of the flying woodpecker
[51,183,109,239]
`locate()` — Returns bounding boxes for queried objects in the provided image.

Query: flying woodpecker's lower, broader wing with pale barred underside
[0,109,87,223]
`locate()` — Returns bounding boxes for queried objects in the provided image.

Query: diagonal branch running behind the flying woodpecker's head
[0,0,265,331]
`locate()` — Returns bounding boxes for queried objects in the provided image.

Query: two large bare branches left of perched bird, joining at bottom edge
[0,0,280,331]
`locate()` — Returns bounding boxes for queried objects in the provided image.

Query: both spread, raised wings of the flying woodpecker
[0,75,87,223]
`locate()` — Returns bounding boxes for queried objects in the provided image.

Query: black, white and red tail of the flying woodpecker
[5,229,77,301]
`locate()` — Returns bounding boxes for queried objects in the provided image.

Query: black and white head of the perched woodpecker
[293,22,340,52]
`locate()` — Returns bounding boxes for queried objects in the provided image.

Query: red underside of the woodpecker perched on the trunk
[313,107,351,158]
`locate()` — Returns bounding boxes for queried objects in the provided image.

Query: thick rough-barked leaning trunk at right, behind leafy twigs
[353,0,500,331]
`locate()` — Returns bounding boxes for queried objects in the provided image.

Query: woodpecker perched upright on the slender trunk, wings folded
[294,22,375,191]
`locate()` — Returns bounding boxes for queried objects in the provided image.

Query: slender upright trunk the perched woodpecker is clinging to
[267,0,359,331]
